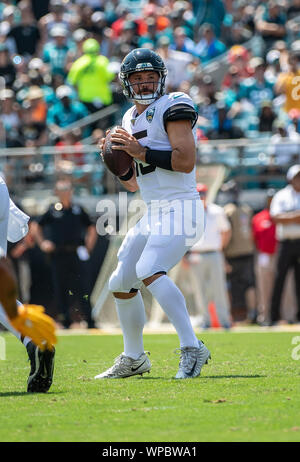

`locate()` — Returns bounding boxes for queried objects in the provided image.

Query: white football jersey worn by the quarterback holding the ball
[122,92,199,205]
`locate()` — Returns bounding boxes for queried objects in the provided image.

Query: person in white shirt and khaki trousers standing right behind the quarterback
[187,183,231,329]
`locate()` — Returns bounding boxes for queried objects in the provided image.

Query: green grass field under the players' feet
[0,332,300,442]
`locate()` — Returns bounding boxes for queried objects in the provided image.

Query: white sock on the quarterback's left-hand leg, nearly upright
[115,291,146,359]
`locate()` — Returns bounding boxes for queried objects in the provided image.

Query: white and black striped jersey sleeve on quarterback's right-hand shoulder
[163,93,198,128]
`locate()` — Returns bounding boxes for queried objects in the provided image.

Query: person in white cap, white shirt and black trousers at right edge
[270,164,300,324]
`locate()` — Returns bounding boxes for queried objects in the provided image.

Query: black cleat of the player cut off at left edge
[26,342,55,393]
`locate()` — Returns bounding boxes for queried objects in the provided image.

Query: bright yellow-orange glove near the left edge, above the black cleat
[10,305,57,350]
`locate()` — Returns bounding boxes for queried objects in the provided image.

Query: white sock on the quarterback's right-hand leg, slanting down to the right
[147,275,199,348]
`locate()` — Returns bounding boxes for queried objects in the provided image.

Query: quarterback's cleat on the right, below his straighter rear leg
[175,340,211,379]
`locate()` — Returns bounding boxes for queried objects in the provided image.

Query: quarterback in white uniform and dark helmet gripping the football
[95,48,210,379]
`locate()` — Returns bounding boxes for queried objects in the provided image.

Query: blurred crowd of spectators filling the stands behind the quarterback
[0,0,300,152]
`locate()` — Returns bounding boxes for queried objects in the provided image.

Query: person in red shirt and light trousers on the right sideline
[252,189,277,324]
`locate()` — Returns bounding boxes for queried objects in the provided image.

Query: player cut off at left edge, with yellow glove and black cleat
[0,177,56,392]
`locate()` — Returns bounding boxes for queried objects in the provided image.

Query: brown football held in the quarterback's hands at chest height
[102,125,133,176]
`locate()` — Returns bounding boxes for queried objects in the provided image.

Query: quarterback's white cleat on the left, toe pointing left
[95,353,151,379]
